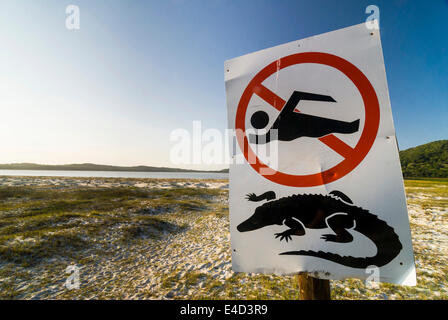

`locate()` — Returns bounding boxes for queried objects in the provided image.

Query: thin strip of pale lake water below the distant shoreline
[0,170,229,179]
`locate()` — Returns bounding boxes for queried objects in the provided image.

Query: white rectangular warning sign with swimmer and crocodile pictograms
[224,23,416,285]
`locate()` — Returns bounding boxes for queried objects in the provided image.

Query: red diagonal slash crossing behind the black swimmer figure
[254,84,353,158]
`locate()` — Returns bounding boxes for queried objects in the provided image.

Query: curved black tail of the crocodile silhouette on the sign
[280,206,403,269]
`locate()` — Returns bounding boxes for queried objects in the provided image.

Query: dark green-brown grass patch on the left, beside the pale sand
[0,187,222,266]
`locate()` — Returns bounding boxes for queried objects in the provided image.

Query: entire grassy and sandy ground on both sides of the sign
[0,179,448,299]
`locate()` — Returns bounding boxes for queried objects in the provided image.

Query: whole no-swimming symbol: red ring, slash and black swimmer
[235,52,380,187]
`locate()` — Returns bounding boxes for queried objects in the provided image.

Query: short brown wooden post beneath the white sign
[296,273,331,300]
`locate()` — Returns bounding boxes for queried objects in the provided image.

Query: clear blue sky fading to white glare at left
[0,0,448,169]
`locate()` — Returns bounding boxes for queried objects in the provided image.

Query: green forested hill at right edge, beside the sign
[400,140,448,178]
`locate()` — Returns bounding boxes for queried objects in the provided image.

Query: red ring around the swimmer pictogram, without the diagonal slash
[235,52,380,187]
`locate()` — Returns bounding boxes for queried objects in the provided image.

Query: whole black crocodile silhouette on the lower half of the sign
[237,191,403,268]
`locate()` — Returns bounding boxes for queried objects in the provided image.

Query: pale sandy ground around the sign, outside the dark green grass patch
[0,177,448,299]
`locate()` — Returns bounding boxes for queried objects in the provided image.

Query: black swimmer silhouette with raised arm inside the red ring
[249,91,359,144]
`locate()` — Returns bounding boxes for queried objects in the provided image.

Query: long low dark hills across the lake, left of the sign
[0,163,229,172]
